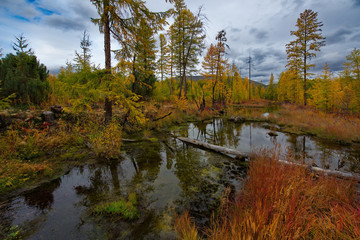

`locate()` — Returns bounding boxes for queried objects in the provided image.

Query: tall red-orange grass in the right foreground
[175,151,360,239]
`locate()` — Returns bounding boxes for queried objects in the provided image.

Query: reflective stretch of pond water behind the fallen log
[181,119,360,171]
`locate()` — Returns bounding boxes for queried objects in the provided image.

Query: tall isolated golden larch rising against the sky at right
[286,9,325,105]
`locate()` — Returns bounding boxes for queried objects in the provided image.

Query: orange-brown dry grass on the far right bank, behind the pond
[270,104,360,142]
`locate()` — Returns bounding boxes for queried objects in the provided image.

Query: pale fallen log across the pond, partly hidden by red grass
[174,136,360,182]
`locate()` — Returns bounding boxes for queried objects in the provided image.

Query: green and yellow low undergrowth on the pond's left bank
[0,113,122,193]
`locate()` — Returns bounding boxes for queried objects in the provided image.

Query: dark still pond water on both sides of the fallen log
[0,119,360,239]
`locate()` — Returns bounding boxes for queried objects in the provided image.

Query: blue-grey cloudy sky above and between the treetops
[0,0,360,83]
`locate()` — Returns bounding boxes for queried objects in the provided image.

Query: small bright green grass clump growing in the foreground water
[93,193,140,220]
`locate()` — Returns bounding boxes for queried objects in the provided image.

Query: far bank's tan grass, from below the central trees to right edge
[227,101,360,143]
